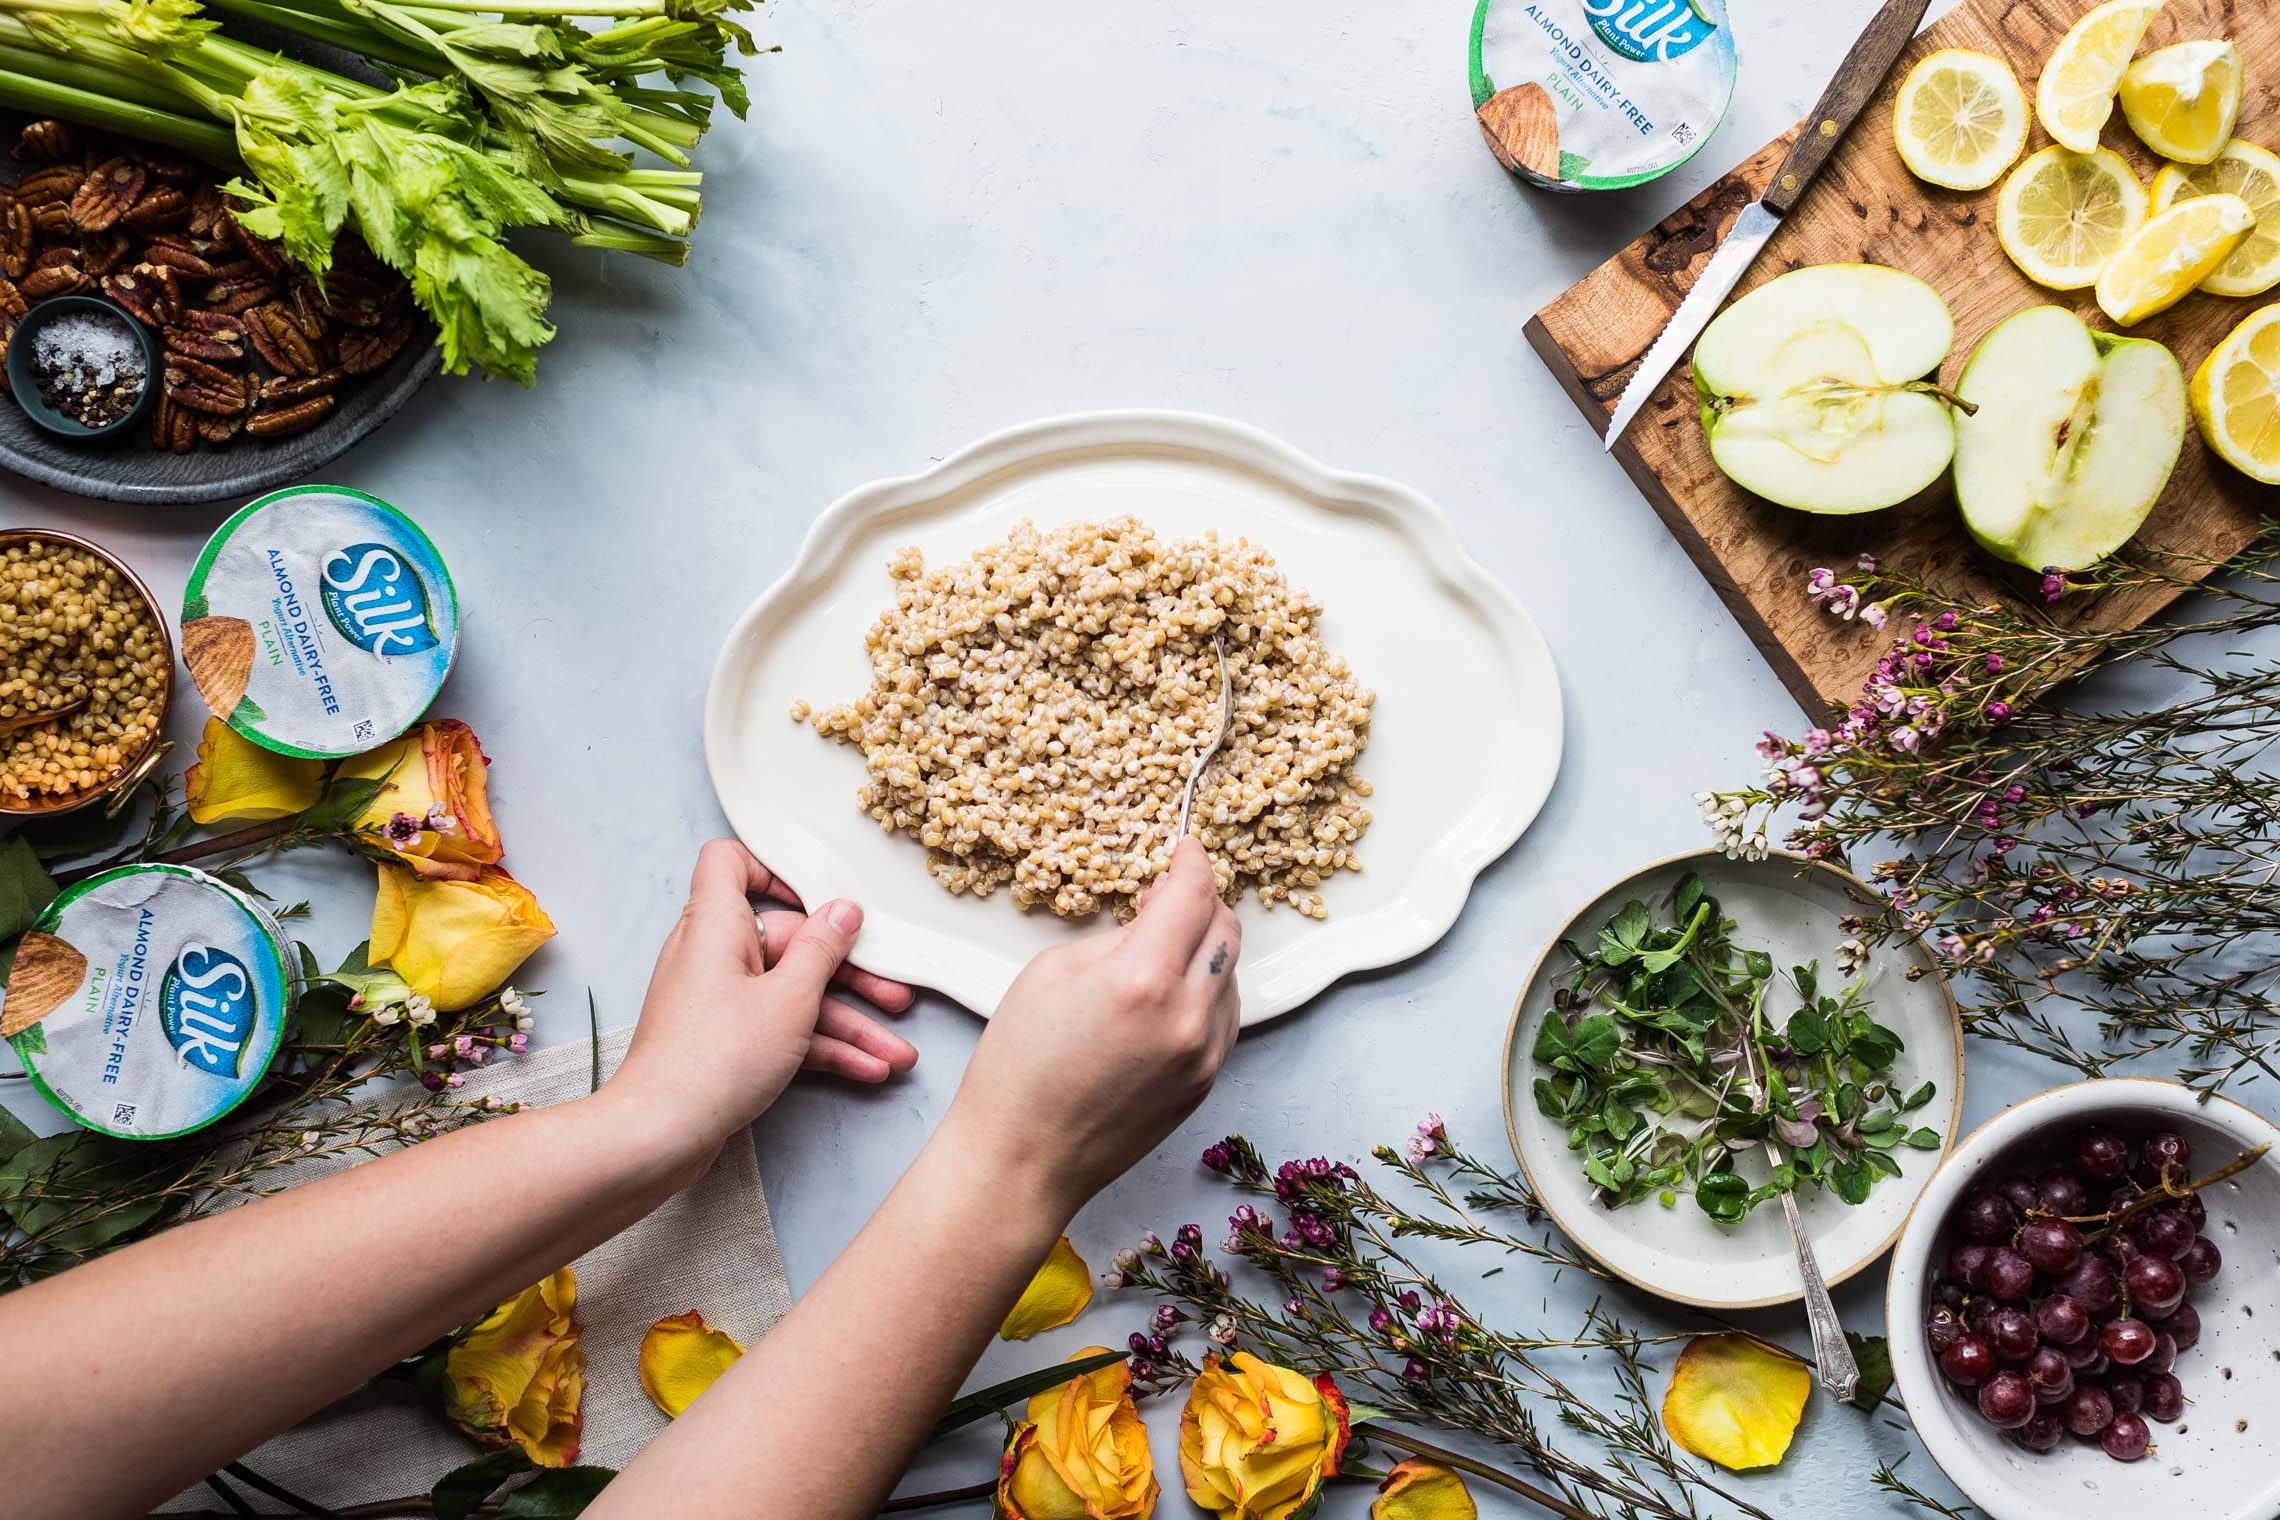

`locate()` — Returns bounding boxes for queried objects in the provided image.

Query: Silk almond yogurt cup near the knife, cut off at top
[1471,0,1735,189]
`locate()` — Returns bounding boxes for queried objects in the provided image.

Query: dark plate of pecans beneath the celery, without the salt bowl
[0,116,442,504]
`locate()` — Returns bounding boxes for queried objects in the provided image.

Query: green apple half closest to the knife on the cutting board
[1694,264,1956,513]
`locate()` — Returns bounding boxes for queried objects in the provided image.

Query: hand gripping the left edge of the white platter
[604,839,919,1162]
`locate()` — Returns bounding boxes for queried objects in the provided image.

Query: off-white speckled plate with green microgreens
[1505,850,1963,1310]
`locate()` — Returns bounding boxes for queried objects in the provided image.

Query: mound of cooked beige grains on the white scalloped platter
[791,517,1373,918]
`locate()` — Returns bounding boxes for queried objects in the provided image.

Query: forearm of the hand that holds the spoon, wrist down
[586,1117,1074,1520]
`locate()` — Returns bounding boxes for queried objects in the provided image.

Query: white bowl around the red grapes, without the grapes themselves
[1886,1078,2280,1520]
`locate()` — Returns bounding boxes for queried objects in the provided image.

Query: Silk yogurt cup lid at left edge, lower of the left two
[0,866,292,1139]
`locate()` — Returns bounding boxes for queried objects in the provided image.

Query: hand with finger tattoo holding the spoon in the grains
[942,839,1243,1217]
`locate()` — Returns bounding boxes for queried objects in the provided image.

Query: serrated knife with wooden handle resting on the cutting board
[1601,0,1931,449]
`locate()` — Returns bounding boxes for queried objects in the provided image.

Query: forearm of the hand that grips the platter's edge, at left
[0,1092,702,1520]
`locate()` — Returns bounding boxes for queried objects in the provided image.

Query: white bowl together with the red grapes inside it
[1886,1078,2280,1520]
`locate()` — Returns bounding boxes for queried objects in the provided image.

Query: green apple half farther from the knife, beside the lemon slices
[1956,305,2187,570]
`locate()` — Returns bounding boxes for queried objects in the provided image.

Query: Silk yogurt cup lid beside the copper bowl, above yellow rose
[182,485,458,759]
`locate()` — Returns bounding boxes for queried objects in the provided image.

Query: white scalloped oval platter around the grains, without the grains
[705,410,1562,1023]
